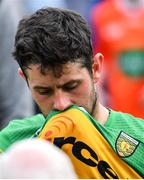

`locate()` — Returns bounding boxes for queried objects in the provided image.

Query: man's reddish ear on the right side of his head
[92,53,104,83]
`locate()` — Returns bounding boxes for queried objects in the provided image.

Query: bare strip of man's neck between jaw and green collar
[92,101,109,125]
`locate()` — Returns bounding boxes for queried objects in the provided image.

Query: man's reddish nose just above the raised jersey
[53,92,72,111]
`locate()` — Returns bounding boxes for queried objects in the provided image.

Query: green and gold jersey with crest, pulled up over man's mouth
[0,106,144,179]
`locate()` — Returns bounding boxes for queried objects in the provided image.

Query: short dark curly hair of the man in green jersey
[13,7,93,74]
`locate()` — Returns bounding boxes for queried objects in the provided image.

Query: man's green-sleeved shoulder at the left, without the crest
[0,114,45,151]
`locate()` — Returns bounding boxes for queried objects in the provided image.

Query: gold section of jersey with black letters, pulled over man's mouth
[38,108,141,179]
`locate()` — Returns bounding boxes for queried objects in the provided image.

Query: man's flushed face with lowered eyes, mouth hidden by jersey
[24,63,96,116]
